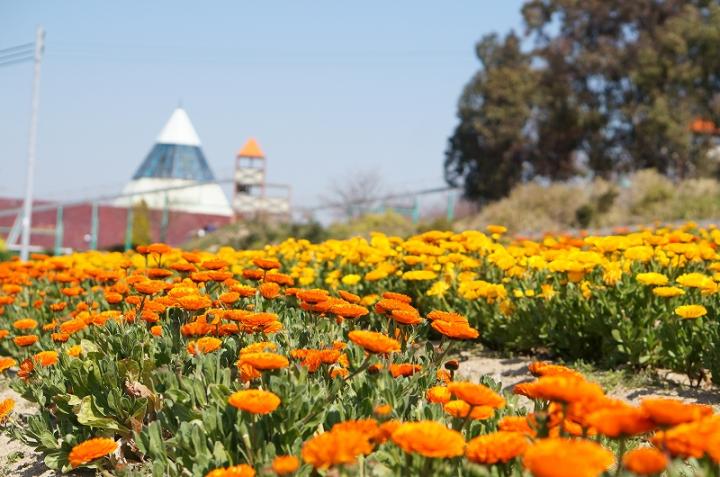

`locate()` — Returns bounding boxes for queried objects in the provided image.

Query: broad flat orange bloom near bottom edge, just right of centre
[390,421,465,458]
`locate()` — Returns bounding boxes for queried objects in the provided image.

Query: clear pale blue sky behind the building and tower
[0,0,522,215]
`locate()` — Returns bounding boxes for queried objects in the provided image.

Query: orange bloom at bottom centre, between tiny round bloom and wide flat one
[302,428,372,469]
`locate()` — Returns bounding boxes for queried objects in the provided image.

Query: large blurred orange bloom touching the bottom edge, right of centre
[523,438,614,477]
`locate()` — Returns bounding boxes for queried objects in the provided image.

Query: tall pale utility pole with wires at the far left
[20,26,45,260]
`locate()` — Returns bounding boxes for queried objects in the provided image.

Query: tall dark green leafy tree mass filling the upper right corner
[445,0,720,201]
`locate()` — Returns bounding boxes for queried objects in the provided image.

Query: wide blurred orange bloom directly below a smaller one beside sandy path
[513,375,604,403]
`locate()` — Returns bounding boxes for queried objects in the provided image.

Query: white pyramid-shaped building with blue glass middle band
[115,108,233,216]
